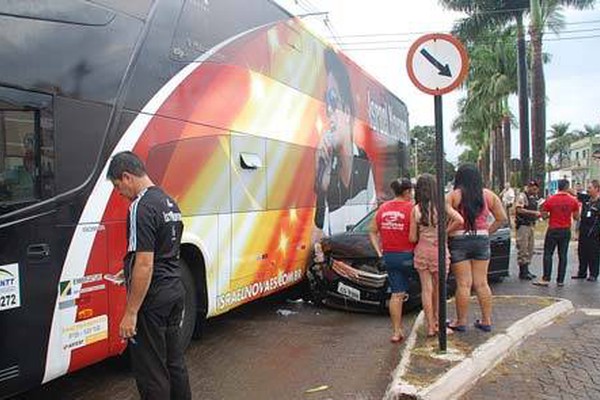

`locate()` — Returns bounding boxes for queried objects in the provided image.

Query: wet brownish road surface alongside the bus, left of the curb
[15,292,415,400]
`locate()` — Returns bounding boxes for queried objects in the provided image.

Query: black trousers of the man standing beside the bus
[129,288,192,400]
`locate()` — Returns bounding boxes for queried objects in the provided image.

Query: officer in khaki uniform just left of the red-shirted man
[515,181,541,280]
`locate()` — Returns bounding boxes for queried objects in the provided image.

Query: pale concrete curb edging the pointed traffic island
[384,296,574,400]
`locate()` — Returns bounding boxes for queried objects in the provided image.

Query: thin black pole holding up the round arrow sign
[434,95,447,353]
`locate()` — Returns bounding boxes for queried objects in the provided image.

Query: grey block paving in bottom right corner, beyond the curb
[463,310,600,400]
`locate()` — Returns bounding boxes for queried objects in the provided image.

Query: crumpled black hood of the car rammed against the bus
[321,232,382,272]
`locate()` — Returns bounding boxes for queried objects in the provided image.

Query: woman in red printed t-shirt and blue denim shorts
[370,179,414,343]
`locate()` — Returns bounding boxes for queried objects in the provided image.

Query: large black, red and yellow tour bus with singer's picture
[0,0,409,398]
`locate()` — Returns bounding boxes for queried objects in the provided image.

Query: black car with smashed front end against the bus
[307,210,510,311]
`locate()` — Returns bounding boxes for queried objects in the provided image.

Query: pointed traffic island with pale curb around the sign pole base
[384,296,572,399]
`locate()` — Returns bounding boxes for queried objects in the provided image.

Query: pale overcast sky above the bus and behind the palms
[277,0,600,162]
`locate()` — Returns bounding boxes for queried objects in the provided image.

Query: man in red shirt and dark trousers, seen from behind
[533,179,579,287]
